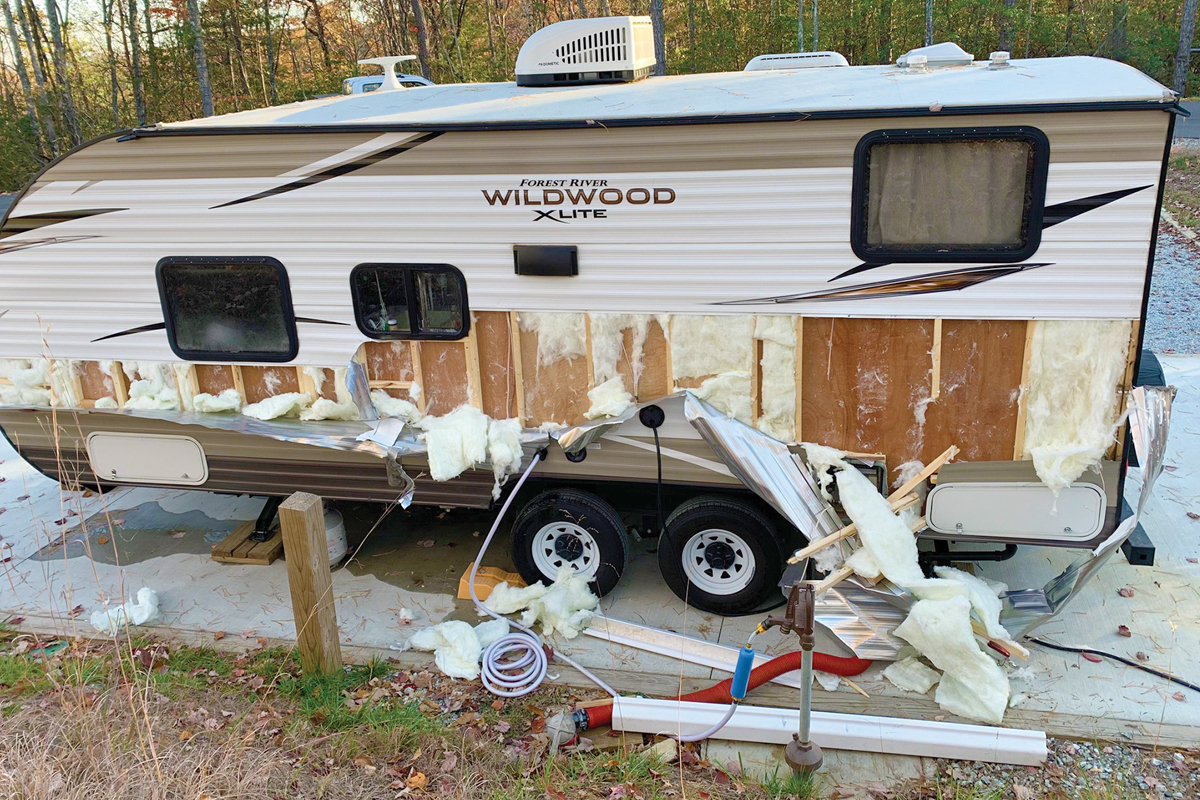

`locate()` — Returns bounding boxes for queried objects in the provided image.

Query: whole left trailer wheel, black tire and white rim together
[512,489,629,597]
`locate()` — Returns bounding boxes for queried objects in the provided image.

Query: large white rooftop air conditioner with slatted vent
[516,17,655,86]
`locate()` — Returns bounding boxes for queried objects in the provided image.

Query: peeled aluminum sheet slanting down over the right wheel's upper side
[683,392,841,539]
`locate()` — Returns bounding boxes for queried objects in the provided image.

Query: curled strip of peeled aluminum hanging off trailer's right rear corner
[1000,386,1175,637]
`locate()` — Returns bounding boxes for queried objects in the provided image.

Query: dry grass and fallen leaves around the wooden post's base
[0,634,792,800]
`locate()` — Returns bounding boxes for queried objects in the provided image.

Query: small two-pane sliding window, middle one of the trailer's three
[350,264,470,339]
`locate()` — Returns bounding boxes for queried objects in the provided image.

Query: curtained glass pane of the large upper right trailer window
[865,139,1034,252]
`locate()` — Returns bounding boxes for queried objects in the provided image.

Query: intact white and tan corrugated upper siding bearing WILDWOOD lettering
[0,112,1166,366]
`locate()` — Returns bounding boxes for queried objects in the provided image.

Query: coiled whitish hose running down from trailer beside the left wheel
[467,450,619,697]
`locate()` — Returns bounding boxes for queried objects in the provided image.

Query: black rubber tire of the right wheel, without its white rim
[659,497,786,616]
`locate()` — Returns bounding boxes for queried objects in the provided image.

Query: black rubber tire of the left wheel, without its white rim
[512,489,629,597]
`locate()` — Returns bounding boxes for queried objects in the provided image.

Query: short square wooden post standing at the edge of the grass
[280,492,342,674]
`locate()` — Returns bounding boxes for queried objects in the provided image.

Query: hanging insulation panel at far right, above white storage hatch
[1025,320,1130,494]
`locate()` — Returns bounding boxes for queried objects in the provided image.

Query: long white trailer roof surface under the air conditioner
[160,56,1176,132]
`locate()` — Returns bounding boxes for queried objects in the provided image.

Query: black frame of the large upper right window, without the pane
[850,125,1050,264]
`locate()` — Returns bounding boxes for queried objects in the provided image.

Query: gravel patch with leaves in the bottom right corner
[907,739,1200,800]
